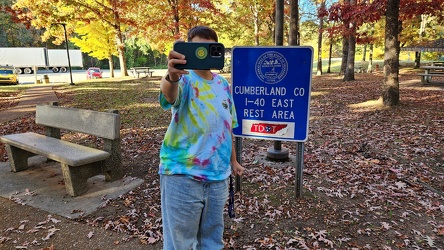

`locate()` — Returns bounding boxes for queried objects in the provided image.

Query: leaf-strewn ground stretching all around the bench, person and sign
[0,73,444,249]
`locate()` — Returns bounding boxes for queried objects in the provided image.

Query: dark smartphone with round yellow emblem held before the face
[173,42,225,69]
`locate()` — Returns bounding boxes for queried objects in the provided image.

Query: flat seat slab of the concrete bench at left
[0,132,110,166]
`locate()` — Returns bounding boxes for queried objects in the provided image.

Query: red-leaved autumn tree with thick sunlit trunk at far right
[329,0,444,106]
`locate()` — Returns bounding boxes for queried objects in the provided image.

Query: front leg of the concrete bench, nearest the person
[61,163,102,196]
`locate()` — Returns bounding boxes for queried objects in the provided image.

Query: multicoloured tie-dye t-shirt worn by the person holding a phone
[159,70,238,181]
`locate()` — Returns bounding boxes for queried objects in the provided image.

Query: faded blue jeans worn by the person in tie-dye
[160,175,228,250]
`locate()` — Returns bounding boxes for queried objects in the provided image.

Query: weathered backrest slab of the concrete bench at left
[35,104,120,140]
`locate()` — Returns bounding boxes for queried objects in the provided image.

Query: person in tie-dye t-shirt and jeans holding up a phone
[159,26,244,250]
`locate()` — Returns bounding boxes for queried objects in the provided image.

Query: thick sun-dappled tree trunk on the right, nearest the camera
[382,0,400,106]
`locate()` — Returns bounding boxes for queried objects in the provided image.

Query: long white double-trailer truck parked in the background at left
[0,47,83,74]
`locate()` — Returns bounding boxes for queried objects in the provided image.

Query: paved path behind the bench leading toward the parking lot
[0,86,58,124]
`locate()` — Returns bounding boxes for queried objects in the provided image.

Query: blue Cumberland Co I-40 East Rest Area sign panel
[232,46,313,142]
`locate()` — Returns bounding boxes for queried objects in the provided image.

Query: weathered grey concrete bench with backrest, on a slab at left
[0,103,123,196]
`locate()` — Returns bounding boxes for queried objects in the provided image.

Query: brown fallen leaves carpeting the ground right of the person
[219,72,444,249]
